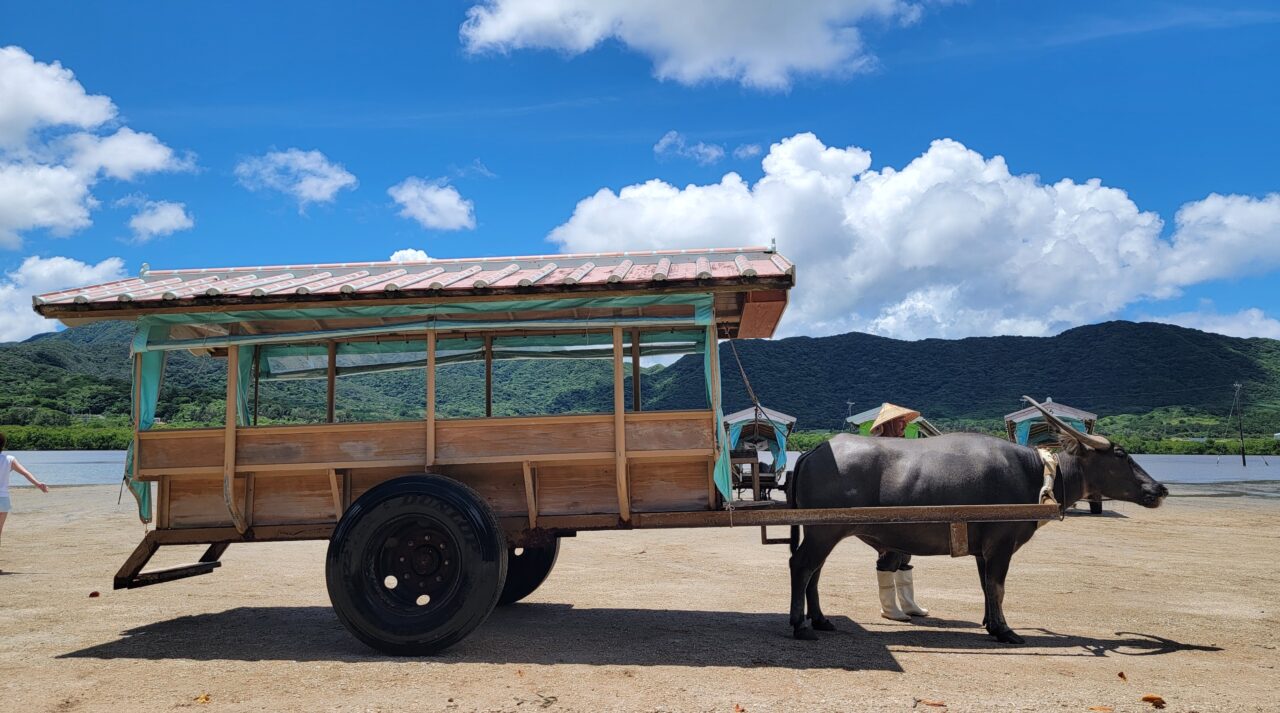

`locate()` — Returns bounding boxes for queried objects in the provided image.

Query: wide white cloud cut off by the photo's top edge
[461,0,920,90]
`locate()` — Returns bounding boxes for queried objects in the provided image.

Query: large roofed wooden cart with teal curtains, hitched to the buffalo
[35,248,1056,654]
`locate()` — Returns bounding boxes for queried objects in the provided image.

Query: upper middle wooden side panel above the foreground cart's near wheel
[435,415,613,462]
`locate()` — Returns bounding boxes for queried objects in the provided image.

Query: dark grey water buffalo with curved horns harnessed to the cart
[787,397,1169,644]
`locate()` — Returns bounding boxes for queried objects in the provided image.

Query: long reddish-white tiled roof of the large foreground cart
[33,247,795,312]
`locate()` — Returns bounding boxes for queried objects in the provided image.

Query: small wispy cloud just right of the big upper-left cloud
[236,148,360,211]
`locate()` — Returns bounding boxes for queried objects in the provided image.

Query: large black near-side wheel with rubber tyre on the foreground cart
[325,475,507,655]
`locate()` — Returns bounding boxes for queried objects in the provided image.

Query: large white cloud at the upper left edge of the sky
[0,47,195,248]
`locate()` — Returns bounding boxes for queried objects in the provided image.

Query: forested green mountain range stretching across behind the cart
[0,321,1280,438]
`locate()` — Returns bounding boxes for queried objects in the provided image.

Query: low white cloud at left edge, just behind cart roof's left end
[0,256,125,342]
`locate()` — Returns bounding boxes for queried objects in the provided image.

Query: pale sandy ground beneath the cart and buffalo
[0,486,1280,713]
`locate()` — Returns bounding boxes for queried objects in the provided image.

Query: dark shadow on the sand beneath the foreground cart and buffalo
[59,603,1220,672]
